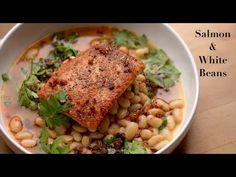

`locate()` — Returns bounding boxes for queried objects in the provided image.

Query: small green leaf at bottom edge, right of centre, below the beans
[124,140,147,154]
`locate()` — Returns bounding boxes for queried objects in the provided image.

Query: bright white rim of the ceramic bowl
[0,23,200,154]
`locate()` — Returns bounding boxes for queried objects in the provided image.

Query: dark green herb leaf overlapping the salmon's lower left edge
[39,90,70,128]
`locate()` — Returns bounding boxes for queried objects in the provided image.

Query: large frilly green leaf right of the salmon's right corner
[142,48,181,89]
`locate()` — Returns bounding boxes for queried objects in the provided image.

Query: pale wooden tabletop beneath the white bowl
[0,24,236,153]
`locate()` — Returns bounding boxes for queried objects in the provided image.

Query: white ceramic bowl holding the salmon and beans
[0,23,199,153]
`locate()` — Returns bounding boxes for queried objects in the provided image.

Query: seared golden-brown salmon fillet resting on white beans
[38,44,144,128]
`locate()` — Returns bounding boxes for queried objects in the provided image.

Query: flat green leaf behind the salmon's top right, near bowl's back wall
[114,30,148,49]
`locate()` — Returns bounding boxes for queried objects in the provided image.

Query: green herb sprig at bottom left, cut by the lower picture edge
[39,127,69,154]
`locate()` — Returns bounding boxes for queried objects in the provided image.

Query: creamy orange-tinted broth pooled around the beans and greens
[1,27,184,153]
